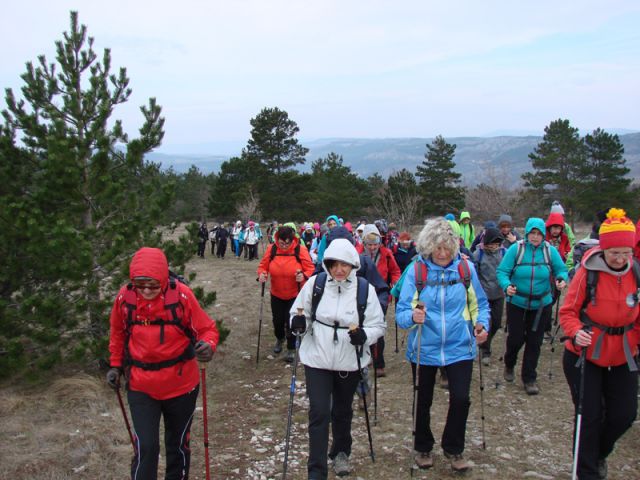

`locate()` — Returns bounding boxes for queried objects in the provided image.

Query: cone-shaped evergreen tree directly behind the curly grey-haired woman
[416,135,465,215]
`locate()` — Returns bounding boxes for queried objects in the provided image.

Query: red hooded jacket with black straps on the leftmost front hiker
[109,247,219,400]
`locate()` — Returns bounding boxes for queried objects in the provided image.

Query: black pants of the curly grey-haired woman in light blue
[411,360,473,455]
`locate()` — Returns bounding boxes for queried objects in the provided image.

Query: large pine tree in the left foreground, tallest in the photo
[0,12,192,374]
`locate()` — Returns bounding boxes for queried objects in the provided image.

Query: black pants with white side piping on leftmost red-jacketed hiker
[127,386,199,480]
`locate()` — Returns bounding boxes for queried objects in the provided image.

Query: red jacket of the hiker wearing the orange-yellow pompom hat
[560,247,640,367]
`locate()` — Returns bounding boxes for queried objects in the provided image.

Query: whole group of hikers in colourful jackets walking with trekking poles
[107,202,640,480]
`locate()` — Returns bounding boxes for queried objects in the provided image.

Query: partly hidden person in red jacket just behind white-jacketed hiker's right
[356,224,402,377]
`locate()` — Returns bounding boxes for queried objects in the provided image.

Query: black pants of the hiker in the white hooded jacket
[304,366,360,480]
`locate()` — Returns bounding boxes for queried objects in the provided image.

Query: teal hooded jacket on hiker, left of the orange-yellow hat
[496,217,568,310]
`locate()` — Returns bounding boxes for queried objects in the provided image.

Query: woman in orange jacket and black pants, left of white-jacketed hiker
[258,226,315,363]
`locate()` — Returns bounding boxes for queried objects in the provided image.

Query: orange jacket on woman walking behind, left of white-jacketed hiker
[258,233,315,300]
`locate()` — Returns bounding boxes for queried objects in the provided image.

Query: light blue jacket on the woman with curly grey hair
[396,257,489,366]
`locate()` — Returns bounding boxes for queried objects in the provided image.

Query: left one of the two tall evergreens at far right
[522,119,587,216]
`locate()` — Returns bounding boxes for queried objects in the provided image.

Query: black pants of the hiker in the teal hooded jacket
[504,302,553,383]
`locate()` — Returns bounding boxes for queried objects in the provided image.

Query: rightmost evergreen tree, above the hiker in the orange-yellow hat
[577,128,635,220]
